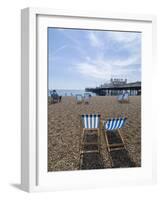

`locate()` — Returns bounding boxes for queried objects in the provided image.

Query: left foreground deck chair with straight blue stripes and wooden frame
[81,114,100,153]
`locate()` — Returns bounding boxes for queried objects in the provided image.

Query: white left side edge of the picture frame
[21,8,37,192]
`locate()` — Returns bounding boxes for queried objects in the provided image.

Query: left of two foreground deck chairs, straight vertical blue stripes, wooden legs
[80,114,100,154]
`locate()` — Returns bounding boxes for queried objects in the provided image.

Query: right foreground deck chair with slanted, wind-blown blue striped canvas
[103,117,127,151]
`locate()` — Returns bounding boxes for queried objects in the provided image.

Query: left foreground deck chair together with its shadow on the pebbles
[80,114,104,169]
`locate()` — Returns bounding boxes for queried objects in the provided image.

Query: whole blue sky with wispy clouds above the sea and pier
[48,28,141,89]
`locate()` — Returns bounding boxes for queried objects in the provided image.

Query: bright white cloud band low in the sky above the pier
[76,52,140,81]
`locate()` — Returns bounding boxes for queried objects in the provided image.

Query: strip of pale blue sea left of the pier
[48,89,96,96]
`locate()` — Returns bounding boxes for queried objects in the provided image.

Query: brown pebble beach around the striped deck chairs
[48,96,141,172]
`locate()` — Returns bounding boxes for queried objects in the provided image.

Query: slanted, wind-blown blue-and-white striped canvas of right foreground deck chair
[104,117,126,131]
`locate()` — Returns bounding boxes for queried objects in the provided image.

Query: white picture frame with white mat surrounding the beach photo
[21,8,156,192]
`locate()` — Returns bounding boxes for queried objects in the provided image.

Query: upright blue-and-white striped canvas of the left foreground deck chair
[82,114,100,129]
